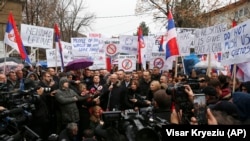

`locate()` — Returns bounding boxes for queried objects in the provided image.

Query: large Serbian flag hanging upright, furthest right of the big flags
[166,11,180,59]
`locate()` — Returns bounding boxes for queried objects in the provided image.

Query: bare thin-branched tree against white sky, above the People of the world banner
[56,0,95,42]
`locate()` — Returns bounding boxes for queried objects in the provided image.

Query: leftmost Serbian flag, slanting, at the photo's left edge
[4,12,31,65]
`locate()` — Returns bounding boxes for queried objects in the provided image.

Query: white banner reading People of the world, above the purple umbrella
[71,38,100,57]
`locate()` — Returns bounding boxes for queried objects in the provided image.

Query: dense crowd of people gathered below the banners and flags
[0,67,250,141]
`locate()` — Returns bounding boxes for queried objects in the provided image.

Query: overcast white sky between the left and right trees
[83,0,165,37]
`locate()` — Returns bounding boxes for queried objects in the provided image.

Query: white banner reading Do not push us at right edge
[221,20,250,65]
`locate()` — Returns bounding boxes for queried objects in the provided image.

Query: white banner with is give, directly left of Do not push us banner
[195,24,227,54]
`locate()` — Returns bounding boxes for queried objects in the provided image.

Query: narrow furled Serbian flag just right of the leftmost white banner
[54,24,64,72]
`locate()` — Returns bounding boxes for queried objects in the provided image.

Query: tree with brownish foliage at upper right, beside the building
[135,0,226,28]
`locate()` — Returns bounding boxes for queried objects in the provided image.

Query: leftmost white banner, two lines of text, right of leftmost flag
[21,24,54,48]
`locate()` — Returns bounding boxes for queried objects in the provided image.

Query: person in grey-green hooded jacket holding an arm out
[55,77,89,124]
